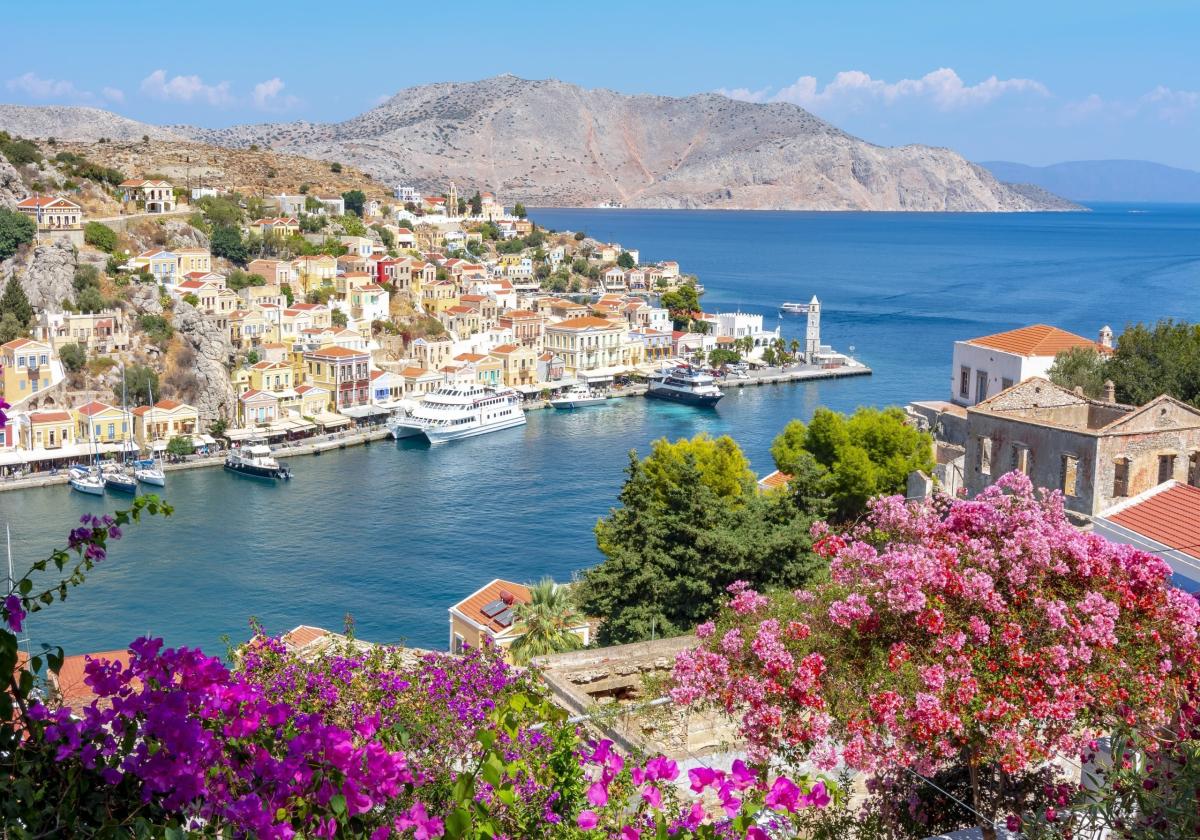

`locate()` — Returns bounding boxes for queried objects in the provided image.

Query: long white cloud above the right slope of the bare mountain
[718,67,1050,110]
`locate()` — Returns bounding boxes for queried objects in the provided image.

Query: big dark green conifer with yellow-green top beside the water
[580,434,823,644]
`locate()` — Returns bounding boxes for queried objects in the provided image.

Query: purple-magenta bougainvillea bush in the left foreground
[0,497,829,840]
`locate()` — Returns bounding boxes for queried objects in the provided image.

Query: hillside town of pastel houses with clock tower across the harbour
[0,139,865,476]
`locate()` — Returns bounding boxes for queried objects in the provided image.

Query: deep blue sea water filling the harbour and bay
[0,204,1200,654]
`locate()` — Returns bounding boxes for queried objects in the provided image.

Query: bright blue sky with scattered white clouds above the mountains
[0,0,1200,169]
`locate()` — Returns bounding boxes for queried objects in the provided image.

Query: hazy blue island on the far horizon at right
[979,161,1200,203]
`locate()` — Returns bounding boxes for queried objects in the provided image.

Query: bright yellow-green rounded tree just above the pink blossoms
[770,408,934,520]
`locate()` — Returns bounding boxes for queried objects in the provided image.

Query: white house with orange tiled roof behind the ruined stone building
[950,324,1112,406]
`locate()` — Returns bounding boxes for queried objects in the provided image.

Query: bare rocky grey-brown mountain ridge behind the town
[0,76,1080,211]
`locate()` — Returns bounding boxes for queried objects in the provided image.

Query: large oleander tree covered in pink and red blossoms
[673,473,1200,838]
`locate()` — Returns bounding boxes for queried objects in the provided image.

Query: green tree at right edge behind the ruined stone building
[1104,320,1200,407]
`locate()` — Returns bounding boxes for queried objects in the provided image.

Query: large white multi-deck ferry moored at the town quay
[388,383,524,443]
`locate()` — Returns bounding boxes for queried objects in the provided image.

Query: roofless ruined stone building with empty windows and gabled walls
[962,378,1200,516]
